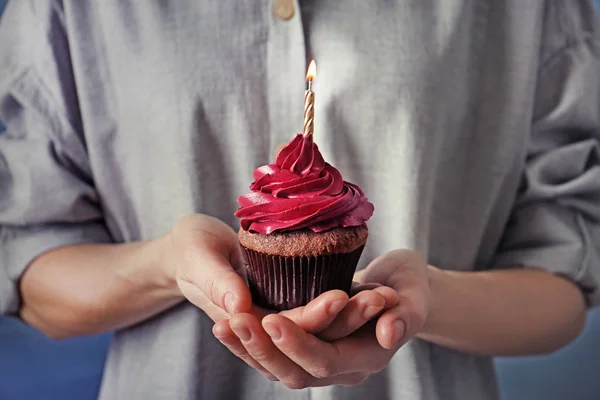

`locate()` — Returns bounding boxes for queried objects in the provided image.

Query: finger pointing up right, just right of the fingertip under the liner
[318,290,386,342]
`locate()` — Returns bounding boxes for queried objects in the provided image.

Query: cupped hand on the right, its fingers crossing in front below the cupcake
[213,250,430,389]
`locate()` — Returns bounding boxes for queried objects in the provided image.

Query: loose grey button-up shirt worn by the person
[0,0,600,400]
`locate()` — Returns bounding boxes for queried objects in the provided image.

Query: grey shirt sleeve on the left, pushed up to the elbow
[0,0,111,314]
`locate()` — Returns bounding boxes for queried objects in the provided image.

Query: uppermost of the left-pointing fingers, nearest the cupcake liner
[262,314,394,379]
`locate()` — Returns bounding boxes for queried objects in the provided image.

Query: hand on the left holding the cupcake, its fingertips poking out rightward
[163,214,370,333]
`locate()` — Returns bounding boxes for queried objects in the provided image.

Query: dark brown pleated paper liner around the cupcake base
[242,246,364,310]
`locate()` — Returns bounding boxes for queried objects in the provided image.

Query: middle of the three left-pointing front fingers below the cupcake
[229,314,313,389]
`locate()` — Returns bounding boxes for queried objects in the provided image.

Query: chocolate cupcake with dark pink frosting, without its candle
[235,134,373,310]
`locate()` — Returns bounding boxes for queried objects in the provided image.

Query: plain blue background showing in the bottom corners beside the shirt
[0,0,600,400]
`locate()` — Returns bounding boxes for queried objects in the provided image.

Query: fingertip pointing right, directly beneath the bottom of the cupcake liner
[280,290,349,334]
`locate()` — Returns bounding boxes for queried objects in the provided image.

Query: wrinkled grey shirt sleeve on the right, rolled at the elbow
[494,1,600,306]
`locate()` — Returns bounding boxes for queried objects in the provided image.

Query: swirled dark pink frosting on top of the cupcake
[235,134,373,234]
